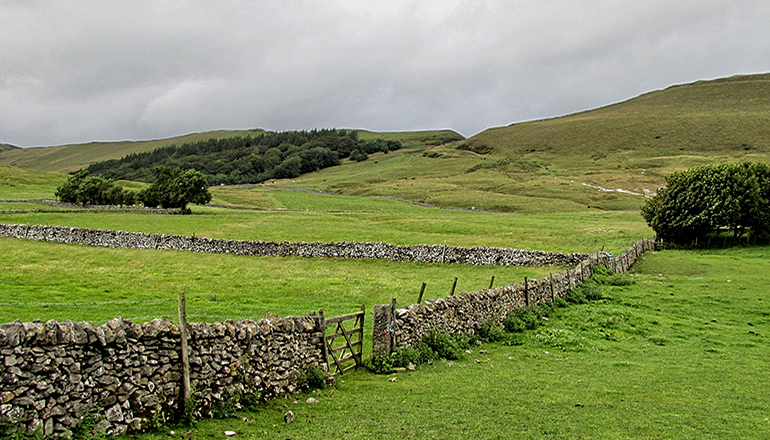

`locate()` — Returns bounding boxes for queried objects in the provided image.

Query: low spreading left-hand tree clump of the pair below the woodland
[54,170,136,206]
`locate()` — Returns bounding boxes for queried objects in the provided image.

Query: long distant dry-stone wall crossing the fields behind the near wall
[0,224,588,266]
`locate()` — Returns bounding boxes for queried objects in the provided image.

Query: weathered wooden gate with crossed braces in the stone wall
[321,304,366,376]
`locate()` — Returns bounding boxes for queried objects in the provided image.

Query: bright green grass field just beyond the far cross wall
[0,201,651,253]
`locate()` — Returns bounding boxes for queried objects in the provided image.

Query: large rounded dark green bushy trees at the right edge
[642,162,770,244]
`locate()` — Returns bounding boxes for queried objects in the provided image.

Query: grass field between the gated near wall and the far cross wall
[0,238,560,322]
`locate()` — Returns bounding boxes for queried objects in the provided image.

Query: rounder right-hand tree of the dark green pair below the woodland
[137,167,211,211]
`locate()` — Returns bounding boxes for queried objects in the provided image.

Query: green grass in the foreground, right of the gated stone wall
[129,247,770,440]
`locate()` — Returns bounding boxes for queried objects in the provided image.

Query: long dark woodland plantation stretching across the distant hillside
[87,129,402,185]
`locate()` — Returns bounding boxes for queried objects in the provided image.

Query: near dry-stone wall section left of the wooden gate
[0,316,327,436]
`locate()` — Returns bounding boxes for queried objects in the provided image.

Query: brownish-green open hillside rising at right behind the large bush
[284,74,770,212]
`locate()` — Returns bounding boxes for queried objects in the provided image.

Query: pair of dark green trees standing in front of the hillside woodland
[55,167,211,211]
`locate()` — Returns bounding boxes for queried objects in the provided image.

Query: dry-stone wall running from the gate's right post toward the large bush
[373,239,655,356]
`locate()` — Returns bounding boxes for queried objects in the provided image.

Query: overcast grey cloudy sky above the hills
[0,0,770,147]
